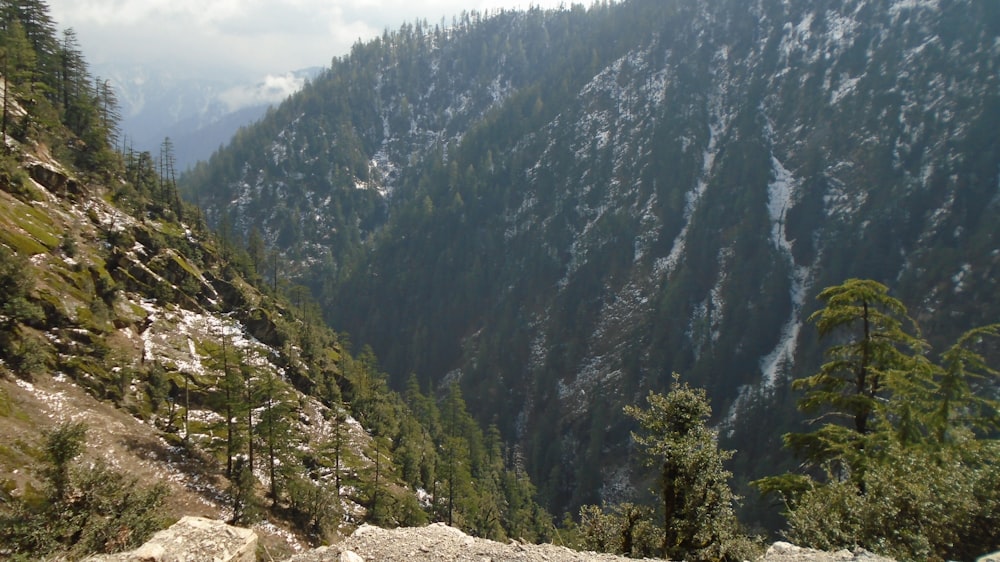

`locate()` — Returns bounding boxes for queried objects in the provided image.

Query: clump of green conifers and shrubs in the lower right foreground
[756,280,1000,559]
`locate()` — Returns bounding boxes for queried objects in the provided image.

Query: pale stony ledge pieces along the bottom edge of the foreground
[89,517,904,562]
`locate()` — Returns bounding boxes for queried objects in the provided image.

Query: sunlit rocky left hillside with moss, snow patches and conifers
[0,0,552,560]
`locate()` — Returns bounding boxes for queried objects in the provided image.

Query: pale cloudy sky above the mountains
[48,0,579,77]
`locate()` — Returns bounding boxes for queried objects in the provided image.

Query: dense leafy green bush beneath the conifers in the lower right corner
[787,438,1000,560]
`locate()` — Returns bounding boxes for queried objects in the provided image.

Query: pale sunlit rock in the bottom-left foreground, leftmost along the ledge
[87,517,258,562]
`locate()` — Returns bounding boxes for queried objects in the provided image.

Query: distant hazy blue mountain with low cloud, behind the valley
[106,66,320,170]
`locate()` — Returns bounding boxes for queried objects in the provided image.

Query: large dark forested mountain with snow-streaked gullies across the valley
[185,0,1000,513]
